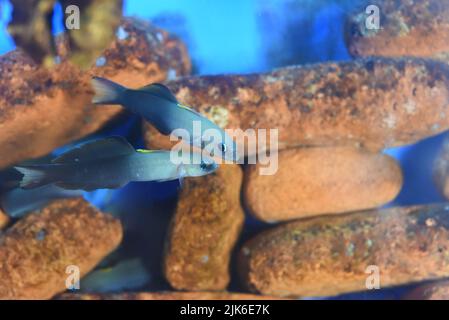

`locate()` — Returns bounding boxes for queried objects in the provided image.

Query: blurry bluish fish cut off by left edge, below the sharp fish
[0,184,83,219]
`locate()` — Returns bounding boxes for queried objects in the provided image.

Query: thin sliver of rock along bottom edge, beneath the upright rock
[57,291,279,300]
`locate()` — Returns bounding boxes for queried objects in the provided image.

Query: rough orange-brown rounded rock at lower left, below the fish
[0,198,122,299]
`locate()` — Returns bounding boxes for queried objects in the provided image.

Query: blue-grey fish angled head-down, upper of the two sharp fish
[92,77,239,162]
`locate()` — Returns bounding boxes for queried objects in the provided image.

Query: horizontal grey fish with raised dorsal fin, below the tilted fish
[15,136,218,191]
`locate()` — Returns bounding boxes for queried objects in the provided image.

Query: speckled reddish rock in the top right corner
[346,0,449,62]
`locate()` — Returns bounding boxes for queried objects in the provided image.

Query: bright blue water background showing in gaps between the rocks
[0,0,445,298]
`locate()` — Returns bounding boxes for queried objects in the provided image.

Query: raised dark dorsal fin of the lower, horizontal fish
[52,136,134,163]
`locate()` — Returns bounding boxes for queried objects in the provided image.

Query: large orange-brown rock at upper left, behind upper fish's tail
[0,19,190,168]
